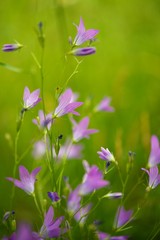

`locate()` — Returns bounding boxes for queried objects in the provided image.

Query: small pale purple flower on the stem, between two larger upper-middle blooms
[33,110,52,130]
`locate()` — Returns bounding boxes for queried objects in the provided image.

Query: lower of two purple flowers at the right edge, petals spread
[142,166,160,190]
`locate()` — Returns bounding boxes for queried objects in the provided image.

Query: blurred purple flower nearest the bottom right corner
[115,207,133,228]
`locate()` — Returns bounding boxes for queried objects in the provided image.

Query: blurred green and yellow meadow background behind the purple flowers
[0,0,160,239]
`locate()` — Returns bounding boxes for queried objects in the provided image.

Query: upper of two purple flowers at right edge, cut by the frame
[148,135,160,167]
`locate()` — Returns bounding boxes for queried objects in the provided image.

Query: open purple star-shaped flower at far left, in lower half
[6,166,41,195]
